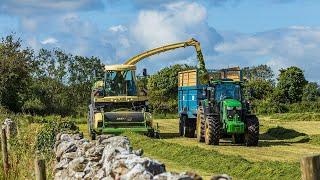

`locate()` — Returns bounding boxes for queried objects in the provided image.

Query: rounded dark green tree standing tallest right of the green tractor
[277,66,307,103]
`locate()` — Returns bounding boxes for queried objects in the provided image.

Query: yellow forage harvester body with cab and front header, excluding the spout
[88,65,154,139]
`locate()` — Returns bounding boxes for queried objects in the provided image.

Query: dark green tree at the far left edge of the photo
[0,35,33,112]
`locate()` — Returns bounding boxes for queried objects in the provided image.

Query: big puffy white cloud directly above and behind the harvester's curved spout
[129,1,222,71]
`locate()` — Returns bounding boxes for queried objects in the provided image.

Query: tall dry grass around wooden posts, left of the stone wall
[0,114,54,179]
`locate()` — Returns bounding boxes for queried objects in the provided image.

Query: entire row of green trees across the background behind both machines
[0,35,320,116]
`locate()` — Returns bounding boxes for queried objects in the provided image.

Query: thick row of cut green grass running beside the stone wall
[125,133,300,179]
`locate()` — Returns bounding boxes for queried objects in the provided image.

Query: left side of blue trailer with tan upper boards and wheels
[178,69,206,137]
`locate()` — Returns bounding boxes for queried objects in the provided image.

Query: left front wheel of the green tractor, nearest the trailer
[204,115,220,145]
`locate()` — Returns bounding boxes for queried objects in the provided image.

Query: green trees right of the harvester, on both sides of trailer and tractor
[148,65,320,114]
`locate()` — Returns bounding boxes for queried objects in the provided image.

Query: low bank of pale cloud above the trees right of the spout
[215,26,320,82]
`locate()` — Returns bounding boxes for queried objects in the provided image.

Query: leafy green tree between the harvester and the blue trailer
[148,64,192,113]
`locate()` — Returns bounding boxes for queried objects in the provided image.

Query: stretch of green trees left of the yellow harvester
[0,35,103,115]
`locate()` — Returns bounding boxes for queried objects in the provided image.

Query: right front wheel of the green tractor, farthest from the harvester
[245,116,259,146]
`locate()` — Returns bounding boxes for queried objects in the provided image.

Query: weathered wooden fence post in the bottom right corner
[300,155,320,180]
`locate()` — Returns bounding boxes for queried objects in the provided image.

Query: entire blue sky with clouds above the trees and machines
[0,0,320,82]
